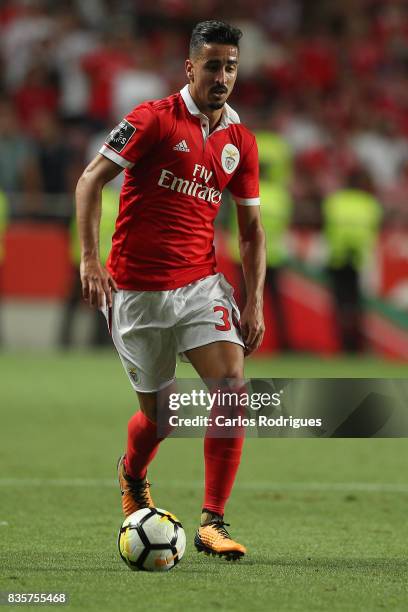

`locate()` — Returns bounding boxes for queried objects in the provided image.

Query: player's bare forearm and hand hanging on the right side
[237,204,266,355]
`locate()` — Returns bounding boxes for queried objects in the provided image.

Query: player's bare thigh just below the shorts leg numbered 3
[185,341,244,383]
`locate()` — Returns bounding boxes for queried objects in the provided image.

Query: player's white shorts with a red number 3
[105,274,244,393]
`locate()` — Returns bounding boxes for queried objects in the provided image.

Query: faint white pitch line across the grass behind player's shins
[0,478,408,493]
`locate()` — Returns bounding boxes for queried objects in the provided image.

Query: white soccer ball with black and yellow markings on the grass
[118,508,186,572]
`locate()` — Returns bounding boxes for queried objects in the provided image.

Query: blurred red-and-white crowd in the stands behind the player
[0,0,408,227]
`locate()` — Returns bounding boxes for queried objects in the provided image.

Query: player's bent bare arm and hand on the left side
[75,155,123,308]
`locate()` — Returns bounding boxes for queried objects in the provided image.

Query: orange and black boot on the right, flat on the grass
[194,518,246,561]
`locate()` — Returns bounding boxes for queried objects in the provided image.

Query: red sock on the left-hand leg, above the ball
[125,410,163,478]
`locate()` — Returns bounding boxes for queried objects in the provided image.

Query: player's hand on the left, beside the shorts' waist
[80,259,118,308]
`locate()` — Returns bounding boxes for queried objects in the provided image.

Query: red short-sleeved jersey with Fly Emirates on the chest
[100,85,259,291]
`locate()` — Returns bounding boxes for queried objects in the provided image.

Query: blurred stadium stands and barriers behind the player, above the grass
[0,0,408,359]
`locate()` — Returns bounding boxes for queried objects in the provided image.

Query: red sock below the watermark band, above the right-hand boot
[203,436,244,515]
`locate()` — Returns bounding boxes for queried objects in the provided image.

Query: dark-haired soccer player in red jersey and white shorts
[76,21,265,559]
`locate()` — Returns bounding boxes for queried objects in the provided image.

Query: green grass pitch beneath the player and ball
[0,351,408,611]
